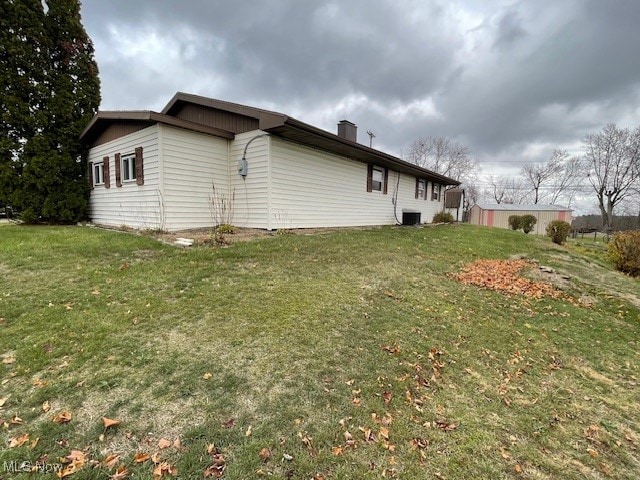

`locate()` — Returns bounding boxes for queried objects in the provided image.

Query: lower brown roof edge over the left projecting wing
[80,110,234,145]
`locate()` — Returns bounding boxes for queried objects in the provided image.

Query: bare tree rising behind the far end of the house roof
[404,137,477,183]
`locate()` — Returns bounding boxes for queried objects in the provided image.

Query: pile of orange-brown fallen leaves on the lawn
[453,260,562,298]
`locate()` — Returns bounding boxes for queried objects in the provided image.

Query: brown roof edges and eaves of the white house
[80,92,460,185]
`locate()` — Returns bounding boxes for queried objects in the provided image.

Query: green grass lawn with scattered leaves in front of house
[0,225,640,480]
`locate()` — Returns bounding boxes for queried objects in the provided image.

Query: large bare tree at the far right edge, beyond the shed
[582,123,640,230]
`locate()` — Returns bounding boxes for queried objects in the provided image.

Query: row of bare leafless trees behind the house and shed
[404,123,640,230]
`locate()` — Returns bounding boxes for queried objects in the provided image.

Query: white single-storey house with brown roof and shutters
[81,93,459,231]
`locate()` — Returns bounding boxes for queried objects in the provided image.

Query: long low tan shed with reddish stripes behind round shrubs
[469,203,573,235]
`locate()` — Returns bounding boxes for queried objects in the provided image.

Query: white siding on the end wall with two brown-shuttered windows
[88,125,162,229]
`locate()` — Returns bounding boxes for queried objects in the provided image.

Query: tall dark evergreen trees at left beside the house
[0,0,100,223]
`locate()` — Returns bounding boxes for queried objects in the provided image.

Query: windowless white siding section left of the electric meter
[160,125,228,231]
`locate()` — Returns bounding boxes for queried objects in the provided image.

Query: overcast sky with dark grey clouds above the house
[82,0,640,214]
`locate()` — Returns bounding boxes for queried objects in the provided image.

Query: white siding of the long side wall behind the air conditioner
[268,137,442,229]
